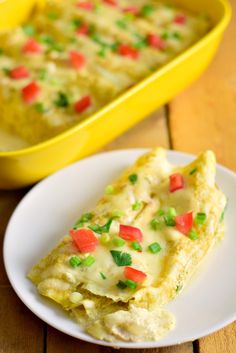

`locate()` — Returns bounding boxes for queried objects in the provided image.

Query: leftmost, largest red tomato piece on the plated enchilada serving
[70,228,98,253]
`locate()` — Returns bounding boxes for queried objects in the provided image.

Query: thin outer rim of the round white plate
[3,148,236,349]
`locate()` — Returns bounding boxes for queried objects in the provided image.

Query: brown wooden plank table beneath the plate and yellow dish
[0,0,236,353]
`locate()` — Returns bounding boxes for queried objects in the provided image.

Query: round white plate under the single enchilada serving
[4,149,236,348]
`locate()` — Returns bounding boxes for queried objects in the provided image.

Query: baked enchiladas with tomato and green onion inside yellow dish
[0,0,210,144]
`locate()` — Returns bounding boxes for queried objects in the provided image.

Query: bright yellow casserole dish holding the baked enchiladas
[0,0,231,189]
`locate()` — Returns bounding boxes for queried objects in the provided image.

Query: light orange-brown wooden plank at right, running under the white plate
[170,0,236,353]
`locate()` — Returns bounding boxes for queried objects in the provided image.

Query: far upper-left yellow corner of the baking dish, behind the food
[0,0,45,30]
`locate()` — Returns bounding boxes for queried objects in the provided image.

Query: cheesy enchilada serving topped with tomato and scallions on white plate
[28,148,226,342]
